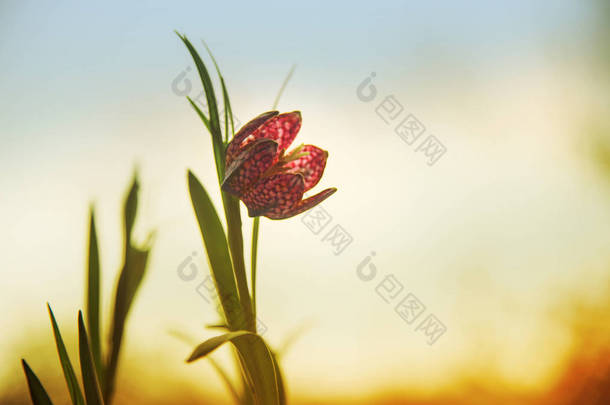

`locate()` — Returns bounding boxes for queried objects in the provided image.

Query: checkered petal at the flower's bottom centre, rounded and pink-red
[242,173,305,217]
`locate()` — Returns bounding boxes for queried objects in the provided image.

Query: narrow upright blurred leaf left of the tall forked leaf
[85,207,103,380]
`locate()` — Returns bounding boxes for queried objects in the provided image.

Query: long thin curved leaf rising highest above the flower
[176,32,225,183]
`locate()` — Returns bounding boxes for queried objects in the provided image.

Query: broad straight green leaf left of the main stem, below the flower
[188,170,244,330]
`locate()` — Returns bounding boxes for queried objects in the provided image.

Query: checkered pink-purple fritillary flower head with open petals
[222,111,337,219]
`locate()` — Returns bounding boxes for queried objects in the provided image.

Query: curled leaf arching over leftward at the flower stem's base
[187,330,281,405]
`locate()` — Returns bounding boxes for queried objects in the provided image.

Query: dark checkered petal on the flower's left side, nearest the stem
[222,139,277,197]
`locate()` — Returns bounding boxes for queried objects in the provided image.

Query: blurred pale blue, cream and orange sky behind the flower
[0,0,610,404]
